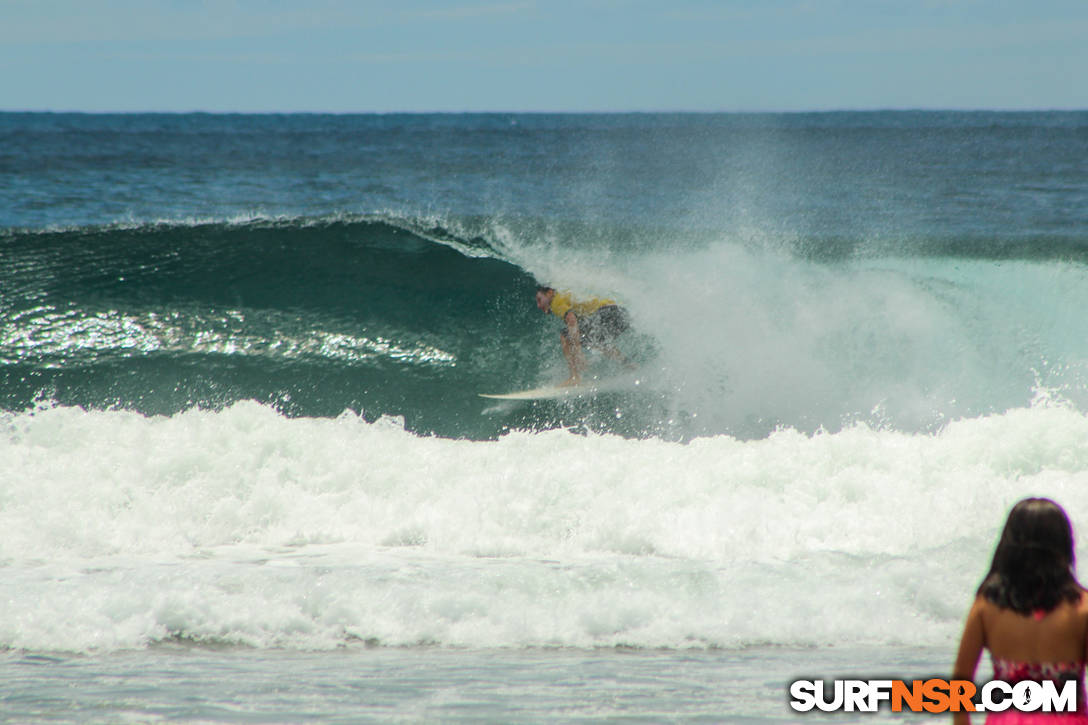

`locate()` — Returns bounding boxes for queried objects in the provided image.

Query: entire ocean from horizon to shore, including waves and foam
[0,111,1088,723]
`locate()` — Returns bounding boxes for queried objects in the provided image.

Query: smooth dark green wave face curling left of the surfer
[0,214,570,437]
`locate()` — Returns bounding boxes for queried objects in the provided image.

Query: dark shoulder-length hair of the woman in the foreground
[978,499,1081,614]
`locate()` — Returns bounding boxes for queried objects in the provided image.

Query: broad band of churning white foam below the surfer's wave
[0,401,1088,651]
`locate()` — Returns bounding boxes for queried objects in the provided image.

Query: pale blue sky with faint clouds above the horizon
[0,0,1088,112]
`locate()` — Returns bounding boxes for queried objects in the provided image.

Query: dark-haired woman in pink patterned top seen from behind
[953,499,1088,725]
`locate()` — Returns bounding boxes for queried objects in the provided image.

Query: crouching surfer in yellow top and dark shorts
[536,285,631,385]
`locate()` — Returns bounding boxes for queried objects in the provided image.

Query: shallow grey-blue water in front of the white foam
[0,644,948,723]
